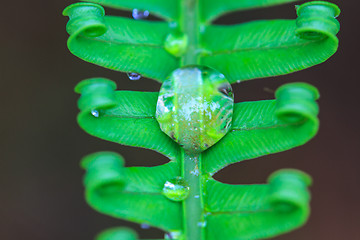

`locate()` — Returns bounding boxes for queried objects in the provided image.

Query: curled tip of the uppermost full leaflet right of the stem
[296,1,340,40]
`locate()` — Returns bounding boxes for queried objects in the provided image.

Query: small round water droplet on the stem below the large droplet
[163,177,190,201]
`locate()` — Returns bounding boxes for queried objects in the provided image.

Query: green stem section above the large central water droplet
[180,0,200,66]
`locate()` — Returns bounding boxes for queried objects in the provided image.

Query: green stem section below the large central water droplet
[182,150,206,240]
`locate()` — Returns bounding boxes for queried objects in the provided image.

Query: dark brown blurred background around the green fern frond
[0,0,360,240]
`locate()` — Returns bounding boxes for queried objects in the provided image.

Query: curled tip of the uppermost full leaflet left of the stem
[63,3,107,37]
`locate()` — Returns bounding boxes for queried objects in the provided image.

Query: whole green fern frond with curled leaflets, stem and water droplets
[64,0,340,240]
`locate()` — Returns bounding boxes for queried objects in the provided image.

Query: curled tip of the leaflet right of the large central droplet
[275,83,320,122]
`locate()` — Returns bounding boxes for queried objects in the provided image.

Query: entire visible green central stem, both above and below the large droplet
[180,0,206,240]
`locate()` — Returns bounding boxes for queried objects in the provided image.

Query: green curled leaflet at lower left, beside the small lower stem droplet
[82,152,182,231]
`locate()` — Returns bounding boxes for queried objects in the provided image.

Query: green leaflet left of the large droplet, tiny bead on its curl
[75,79,180,159]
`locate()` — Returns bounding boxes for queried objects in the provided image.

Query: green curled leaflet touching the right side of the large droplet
[203,83,319,174]
